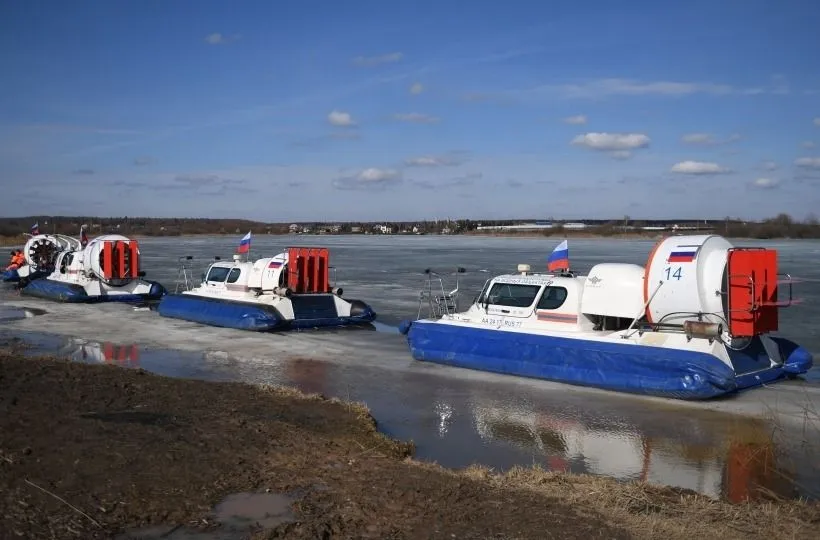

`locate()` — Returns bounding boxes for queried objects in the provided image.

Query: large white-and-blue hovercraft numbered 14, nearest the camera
[400,235,812,400]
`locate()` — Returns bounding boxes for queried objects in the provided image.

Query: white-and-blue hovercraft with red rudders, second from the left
[21,234,166,303]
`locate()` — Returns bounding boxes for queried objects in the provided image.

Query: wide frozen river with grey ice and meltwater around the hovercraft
[0,235,820,500]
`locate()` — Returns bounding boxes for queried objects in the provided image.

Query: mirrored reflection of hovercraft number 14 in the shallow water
[473,403,793,502]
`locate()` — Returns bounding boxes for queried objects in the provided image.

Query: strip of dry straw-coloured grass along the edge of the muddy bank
[6,343,820,540]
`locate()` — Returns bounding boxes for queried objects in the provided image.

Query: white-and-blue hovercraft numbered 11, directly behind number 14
[157,247,376,332]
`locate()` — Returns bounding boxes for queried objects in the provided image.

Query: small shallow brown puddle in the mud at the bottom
[117,493,295,540]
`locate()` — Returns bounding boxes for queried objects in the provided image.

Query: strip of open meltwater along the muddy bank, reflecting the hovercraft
[4,332,820,502]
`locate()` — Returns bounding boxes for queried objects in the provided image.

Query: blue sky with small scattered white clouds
[0,0,820,222]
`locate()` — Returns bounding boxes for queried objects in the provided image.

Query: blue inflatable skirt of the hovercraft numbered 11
[157,294,376,332]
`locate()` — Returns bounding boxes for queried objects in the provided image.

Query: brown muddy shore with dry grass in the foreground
[0,350,820,539]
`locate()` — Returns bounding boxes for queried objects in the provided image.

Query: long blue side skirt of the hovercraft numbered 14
[403,322,737,400]
